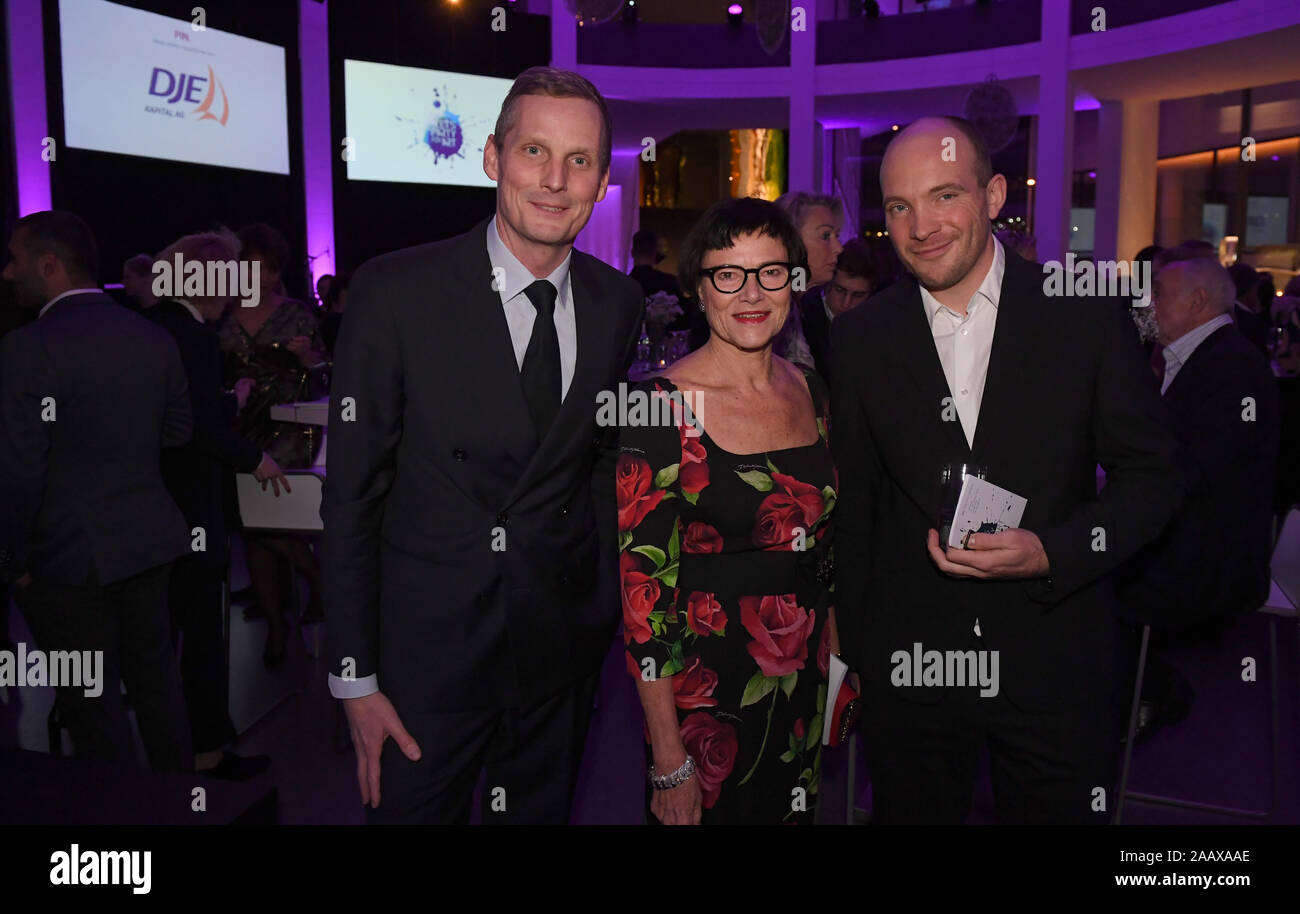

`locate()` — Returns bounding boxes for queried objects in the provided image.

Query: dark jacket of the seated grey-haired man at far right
[1119,325,1279,629]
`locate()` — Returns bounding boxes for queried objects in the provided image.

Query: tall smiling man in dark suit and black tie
[321,68,644,823]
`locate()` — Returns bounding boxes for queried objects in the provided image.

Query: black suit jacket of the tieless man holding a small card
[831,256,1182,709]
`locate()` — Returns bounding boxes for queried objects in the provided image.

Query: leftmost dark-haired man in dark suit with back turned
[0,211,194,771]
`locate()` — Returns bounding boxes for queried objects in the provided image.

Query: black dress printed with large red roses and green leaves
[616,372,836,824]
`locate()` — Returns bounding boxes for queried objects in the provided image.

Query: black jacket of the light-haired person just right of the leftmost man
[146,299,261,571]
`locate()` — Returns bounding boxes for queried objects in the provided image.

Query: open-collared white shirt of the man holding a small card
[920,238,1006,446]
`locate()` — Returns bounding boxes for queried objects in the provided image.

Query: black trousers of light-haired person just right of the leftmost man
[168,554,235,753]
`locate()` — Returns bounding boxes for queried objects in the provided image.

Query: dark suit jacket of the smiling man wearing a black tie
[321,221,644,711]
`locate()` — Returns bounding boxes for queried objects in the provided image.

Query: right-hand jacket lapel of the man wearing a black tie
[510,251,614,503]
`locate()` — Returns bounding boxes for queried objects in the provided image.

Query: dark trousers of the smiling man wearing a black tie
[365,673,598,824]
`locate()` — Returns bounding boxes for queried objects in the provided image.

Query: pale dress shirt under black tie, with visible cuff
[329,216,577,698]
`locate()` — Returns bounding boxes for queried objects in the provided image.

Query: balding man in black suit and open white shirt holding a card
[831,118,1180,823]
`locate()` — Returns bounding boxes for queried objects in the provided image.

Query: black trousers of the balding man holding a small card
[863,636,1119,824]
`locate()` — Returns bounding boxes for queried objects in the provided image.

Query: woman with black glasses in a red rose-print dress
[618,199,839,824]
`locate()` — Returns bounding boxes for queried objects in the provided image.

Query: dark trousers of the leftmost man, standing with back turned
[14,563,194,771]
